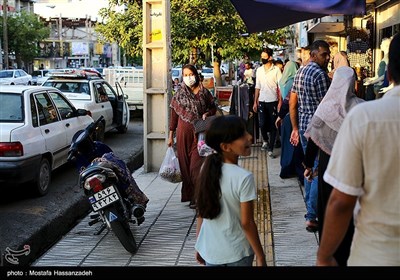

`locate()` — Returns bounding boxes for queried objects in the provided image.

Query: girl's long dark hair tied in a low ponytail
[196,115,246,219]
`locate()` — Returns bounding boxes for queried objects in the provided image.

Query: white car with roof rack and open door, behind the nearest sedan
[43,70,130,141]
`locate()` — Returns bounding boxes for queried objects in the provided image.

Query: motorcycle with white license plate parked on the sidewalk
[68,116,148,254]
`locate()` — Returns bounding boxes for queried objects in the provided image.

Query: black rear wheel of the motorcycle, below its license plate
[104,208,137,254]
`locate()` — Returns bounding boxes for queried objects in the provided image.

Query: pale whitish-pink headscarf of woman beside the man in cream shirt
[304,66,364,155]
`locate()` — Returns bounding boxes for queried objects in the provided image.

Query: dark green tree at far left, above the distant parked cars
[0,11,50,68]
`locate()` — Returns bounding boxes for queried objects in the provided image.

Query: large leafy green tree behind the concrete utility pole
[96,0,289,85]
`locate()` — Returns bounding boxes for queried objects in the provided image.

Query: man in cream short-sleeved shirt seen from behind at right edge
[317,33,400,266]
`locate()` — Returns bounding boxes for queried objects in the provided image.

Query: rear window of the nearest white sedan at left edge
[0,92,23,122]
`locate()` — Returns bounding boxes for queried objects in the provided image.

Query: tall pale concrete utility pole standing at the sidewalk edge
[143,0,171,172]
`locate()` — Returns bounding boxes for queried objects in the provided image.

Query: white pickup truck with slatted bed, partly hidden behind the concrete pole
[103,67,143,111]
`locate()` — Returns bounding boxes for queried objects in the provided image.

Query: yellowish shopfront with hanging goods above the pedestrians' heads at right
[286,0,400,97]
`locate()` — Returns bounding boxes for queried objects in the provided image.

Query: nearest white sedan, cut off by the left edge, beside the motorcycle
[0,86,93,196]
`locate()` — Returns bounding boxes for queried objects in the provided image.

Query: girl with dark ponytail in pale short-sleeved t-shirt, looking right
[195,115,266,266]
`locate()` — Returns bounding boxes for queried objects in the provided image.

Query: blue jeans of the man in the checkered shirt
[299,129,318,221]
